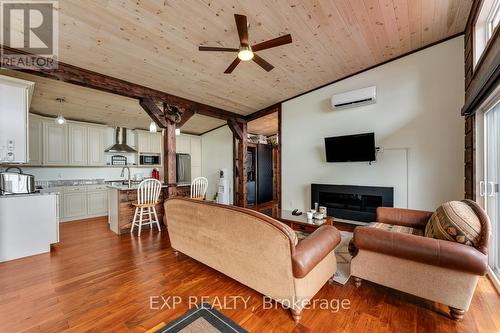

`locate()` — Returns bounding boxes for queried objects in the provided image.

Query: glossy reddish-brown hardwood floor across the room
[0,219,500,333]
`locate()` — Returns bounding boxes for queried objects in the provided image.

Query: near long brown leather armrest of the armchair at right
[353,227,488,275]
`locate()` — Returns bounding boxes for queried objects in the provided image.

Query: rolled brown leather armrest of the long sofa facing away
[292,225,340,278]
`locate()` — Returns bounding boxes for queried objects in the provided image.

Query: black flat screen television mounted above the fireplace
[325,133,375,162]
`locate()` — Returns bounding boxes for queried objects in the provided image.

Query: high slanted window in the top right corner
[474,0,500,67]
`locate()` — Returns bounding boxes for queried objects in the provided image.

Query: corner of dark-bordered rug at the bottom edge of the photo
[152,303,247,333]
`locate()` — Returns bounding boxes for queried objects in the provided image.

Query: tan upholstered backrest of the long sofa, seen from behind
[165,199,297,298]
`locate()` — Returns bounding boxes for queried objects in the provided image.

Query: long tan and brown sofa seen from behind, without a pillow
[165,198,340,323]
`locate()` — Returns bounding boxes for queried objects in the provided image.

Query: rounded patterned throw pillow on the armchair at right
[425,201,481,247]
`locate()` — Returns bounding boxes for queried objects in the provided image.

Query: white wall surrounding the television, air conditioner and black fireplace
[281,36,464,210]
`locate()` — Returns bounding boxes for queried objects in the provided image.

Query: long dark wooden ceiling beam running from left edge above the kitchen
[0,46,243,121]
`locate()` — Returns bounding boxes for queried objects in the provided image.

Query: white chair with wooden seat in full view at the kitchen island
[130,178,161,236]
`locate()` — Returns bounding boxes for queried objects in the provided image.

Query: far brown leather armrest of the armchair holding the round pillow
[377,207,432,229]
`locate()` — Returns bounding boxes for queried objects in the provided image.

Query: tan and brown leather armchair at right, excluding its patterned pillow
[351,201,490,320]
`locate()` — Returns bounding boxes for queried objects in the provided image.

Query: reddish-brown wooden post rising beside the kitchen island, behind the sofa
[163,120,177,198]
